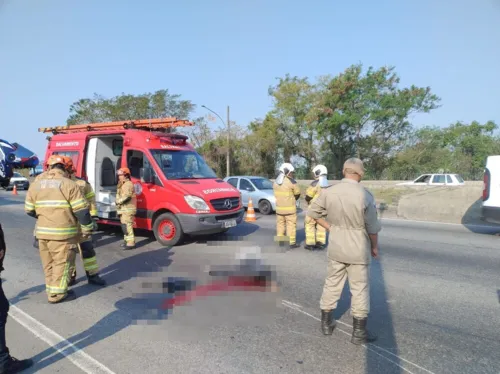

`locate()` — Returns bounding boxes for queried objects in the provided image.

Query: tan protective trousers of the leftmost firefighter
[38,239,78,302]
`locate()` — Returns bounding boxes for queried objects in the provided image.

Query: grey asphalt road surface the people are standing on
[0,191,500,374]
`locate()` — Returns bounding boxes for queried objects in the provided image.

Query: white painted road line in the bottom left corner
[9,305,116,374]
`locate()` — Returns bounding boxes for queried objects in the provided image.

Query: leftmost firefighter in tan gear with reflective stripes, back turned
[24,156,93,304]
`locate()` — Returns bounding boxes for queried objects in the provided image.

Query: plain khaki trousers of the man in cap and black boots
[320,259,370,318]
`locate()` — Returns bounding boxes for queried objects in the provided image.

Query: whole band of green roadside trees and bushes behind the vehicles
[63,64,500,183]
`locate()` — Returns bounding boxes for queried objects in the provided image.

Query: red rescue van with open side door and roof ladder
[38,118,244,246]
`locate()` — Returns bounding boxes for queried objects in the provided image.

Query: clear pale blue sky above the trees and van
[0,0,500,158]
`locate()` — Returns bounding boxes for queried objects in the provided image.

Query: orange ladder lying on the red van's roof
[38,117,194,135]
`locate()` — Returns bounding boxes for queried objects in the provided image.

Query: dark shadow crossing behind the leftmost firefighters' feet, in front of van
[9,248,173,305]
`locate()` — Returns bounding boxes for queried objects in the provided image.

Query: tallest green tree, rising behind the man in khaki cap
[316,64,440,176]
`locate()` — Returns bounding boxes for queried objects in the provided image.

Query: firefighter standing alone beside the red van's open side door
[116,168,137,249]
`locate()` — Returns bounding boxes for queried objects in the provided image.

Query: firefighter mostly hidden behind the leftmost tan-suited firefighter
[66,157,106,286]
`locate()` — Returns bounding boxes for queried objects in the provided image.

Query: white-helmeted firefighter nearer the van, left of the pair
[273,163,300,248]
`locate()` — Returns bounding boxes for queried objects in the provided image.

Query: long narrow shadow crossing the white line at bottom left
[25,294,178,373]
